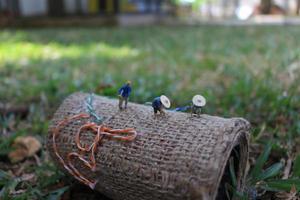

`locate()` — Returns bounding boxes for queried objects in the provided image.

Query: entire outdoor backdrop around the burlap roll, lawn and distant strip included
[0,0,300,199]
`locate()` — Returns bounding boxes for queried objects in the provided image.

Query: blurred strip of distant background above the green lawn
[0,0,300,25]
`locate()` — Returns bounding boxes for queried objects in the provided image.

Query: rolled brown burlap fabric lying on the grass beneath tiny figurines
[47,93,250,200]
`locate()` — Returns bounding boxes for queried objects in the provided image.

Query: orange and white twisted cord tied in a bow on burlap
[52,113,137,189]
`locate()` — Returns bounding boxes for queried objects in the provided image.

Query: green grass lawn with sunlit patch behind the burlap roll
[0,26,300,199]
